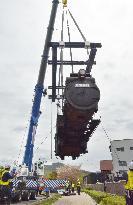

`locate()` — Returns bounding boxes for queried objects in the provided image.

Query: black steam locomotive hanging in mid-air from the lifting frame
[55,69,100,159]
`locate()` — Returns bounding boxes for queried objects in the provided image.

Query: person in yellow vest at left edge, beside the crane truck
[0,165,14,203]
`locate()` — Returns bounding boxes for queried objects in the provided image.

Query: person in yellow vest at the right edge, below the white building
[125,161,133,205]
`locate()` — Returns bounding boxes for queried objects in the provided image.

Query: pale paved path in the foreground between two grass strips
[53,193,96,205]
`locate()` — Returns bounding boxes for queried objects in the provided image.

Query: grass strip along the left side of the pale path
[34,194,61,205]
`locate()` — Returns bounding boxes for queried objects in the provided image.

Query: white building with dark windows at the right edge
[110,139,133,175]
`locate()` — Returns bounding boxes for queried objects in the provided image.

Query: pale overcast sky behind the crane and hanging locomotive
[0,0,133,170]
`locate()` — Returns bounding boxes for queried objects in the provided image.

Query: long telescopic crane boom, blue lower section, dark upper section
[22,0,59,171]
